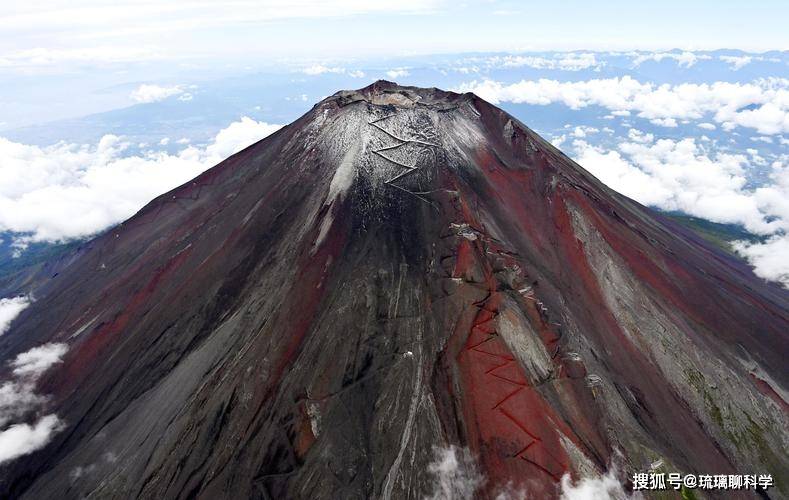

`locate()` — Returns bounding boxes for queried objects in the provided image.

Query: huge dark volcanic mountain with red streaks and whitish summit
[0,81,789,499]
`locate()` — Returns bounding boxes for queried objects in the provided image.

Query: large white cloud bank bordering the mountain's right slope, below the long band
[572,137,789,287]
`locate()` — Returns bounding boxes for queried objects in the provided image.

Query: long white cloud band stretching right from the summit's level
[457,76,789,135]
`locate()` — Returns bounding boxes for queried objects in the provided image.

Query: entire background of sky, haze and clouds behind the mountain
[0,0,789,286]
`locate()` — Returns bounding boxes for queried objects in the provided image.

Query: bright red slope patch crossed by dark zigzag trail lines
[442,186,583,496]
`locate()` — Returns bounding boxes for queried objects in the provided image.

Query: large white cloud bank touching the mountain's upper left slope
[0,117,280,241]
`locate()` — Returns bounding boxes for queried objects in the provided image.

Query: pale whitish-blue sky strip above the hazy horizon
[0,0,789,67]
